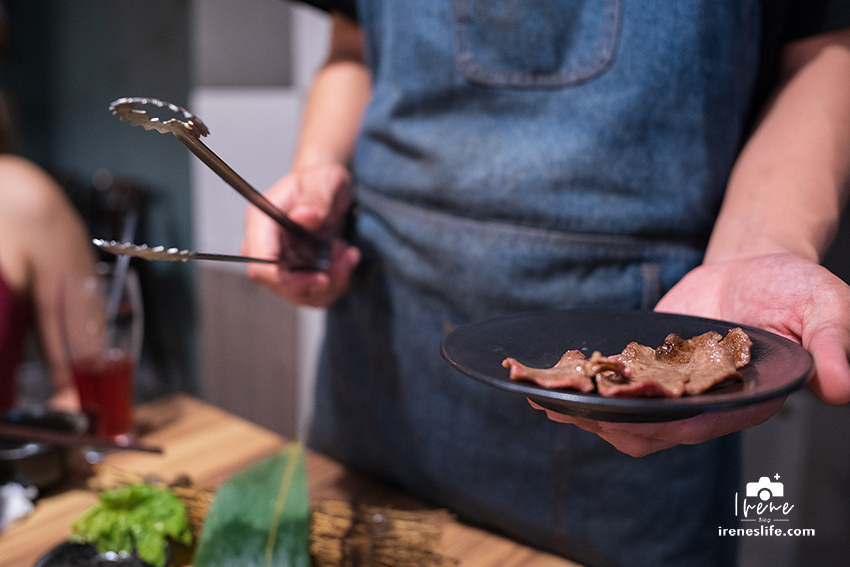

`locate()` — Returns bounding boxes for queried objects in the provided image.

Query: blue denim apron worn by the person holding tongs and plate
[309,0,759,567]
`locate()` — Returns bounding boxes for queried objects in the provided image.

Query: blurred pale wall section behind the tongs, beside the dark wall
[189,0,330,437]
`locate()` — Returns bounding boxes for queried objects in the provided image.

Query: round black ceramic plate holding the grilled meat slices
[440,309,813,423]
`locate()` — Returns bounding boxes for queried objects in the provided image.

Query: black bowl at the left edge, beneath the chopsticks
[0,407,88,491]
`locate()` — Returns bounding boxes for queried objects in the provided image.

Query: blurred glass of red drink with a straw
[59,263,143,442]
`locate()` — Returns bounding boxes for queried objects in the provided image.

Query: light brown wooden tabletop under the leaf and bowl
[0,395,580,567]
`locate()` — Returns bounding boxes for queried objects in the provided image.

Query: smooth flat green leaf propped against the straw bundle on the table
[194,443,310,567]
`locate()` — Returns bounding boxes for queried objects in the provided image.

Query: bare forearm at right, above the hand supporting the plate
[706,30,850,263]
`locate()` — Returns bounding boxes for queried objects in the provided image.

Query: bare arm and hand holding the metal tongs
[242,15,371,307]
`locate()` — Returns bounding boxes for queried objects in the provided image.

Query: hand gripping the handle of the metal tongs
[242,164,360,307]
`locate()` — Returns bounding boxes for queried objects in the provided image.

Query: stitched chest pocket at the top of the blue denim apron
[454,0,620,89]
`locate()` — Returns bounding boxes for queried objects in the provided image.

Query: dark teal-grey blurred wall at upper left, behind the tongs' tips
[0,0,195,398]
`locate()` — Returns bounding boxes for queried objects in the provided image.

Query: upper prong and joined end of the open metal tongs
[109,98,331,270]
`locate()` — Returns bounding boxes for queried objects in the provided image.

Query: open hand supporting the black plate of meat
[533,254,850,456]
